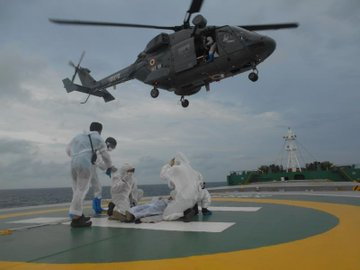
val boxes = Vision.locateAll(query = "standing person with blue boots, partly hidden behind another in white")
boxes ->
[91,137,117,214]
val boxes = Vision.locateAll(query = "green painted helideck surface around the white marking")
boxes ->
[0,191,360,269]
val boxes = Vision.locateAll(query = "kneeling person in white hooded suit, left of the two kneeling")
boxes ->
[108,163,144,222]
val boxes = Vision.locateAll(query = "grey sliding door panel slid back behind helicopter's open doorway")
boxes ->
[171,37,197,72]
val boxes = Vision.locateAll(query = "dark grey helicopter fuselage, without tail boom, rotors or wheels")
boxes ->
[134,26,276,96]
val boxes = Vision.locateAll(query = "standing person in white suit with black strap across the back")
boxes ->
[66,122,112,227]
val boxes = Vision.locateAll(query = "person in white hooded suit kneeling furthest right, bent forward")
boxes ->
[160,153,202,221]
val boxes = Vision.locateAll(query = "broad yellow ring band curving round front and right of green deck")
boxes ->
[0,198,360,270]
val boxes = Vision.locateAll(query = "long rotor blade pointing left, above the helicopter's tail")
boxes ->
[49,19,177,31]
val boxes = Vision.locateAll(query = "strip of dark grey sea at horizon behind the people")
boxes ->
[0,182,227,209]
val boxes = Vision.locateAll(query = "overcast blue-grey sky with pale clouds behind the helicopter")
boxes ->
[0,0,360,189]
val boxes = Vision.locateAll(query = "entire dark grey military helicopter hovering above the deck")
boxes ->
[49,0,298,108]
